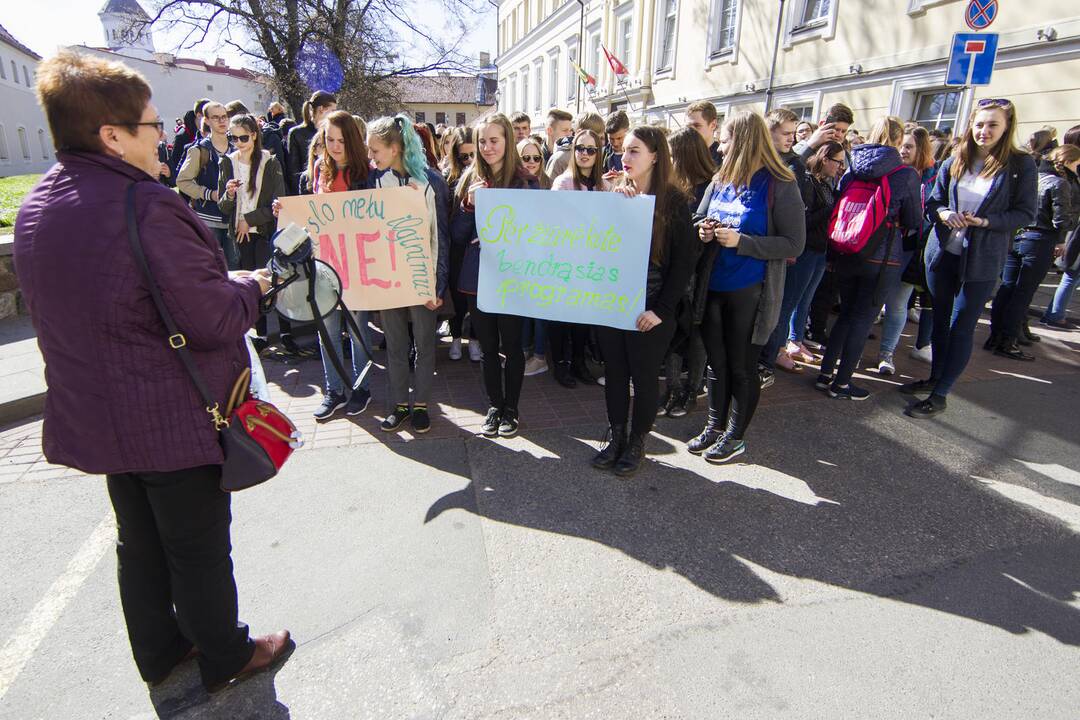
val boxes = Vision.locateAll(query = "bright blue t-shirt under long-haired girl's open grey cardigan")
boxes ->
[708,167,770,291]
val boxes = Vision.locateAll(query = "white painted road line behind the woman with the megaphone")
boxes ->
[0,515,117,701]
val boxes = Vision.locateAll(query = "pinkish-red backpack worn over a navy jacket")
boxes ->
[828,165,904,260]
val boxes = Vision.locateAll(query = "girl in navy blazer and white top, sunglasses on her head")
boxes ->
[900,99,1038,418]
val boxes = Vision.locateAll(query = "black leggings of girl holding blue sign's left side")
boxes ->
[467,295,525,412]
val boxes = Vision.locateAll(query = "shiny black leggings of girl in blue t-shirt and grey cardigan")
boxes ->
[701,283,761,439]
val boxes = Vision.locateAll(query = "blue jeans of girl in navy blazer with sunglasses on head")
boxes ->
[927,252,995,396]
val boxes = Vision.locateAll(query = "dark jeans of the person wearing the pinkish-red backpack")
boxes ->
[821,264,902,386]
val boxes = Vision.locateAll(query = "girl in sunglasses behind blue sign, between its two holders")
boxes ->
[548,130,611,388]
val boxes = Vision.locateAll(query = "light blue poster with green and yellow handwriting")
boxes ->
[476,190,654,330]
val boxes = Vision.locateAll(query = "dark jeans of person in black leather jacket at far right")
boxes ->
[990,231,1058,340]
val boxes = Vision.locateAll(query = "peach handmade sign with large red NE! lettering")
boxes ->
[278,187,435,310]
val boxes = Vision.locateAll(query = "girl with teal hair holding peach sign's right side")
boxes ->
[367,114,450,433]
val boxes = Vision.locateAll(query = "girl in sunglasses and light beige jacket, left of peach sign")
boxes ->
[217,114,285,351]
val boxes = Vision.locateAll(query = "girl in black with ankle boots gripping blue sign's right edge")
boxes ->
[591,125,698,477]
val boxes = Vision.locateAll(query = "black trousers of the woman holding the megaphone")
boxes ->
[106,465,255,685]
